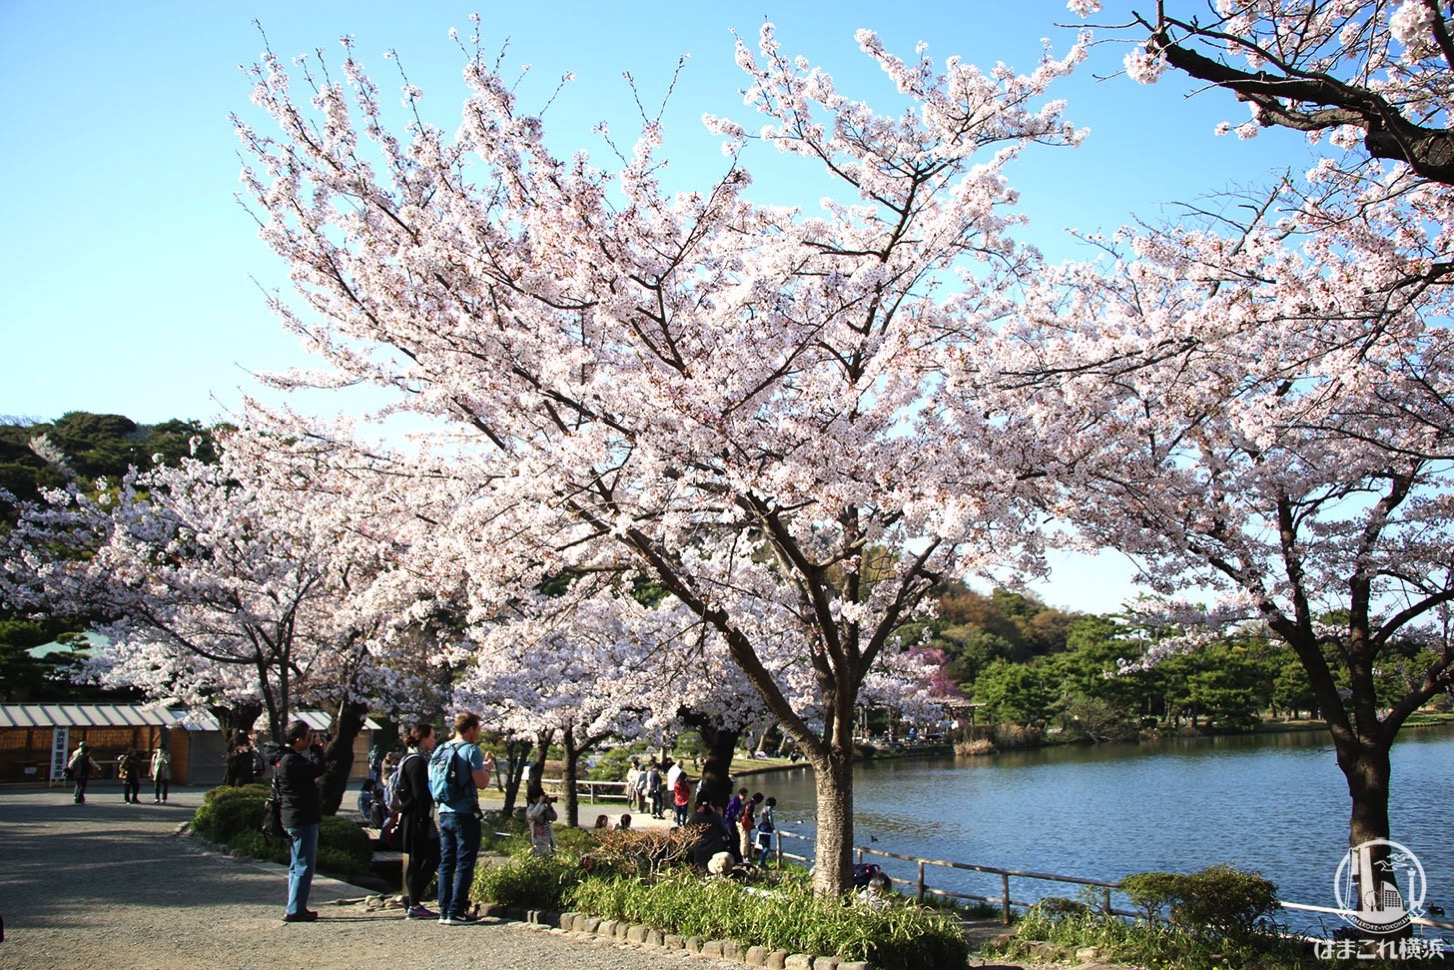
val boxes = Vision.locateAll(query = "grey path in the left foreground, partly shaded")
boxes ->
[0,787,743,970]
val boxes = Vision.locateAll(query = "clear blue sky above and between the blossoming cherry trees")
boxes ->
[0,0,1309,609]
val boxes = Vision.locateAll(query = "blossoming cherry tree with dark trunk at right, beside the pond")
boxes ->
[974,172,1454,901]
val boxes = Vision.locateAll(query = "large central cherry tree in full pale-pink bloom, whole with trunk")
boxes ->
[236,26,1083,893]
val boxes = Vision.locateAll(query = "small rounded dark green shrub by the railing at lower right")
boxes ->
[1121,865,1277,938]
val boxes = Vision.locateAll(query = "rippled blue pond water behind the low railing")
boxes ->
[749,727,1454,930]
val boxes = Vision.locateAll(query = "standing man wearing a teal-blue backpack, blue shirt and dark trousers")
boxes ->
[429,711,490,926]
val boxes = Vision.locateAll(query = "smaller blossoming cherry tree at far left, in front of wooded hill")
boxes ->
[6,432,425,762]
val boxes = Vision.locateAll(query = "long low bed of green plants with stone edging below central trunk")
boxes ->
[566,870,970,970]
